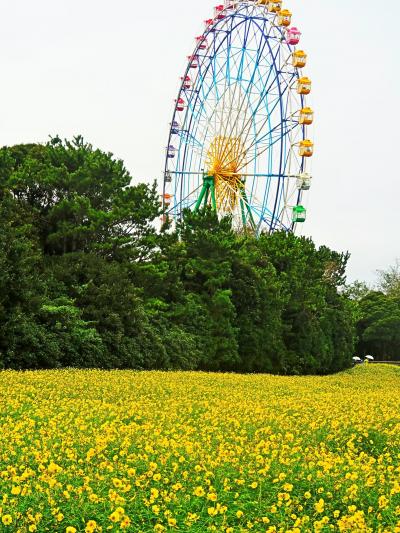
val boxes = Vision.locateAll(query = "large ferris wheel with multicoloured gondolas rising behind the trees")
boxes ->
[163,0,314,234]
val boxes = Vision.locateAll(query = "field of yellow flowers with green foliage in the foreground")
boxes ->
[0,365,400,533]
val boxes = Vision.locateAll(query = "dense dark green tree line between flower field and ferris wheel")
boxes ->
[0,137,357,374]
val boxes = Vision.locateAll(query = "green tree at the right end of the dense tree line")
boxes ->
[260,232,354,374]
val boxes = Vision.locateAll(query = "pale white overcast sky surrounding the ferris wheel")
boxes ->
[0,0,400,281]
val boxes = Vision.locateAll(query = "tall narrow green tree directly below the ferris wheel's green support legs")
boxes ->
[176,209,239,370]
